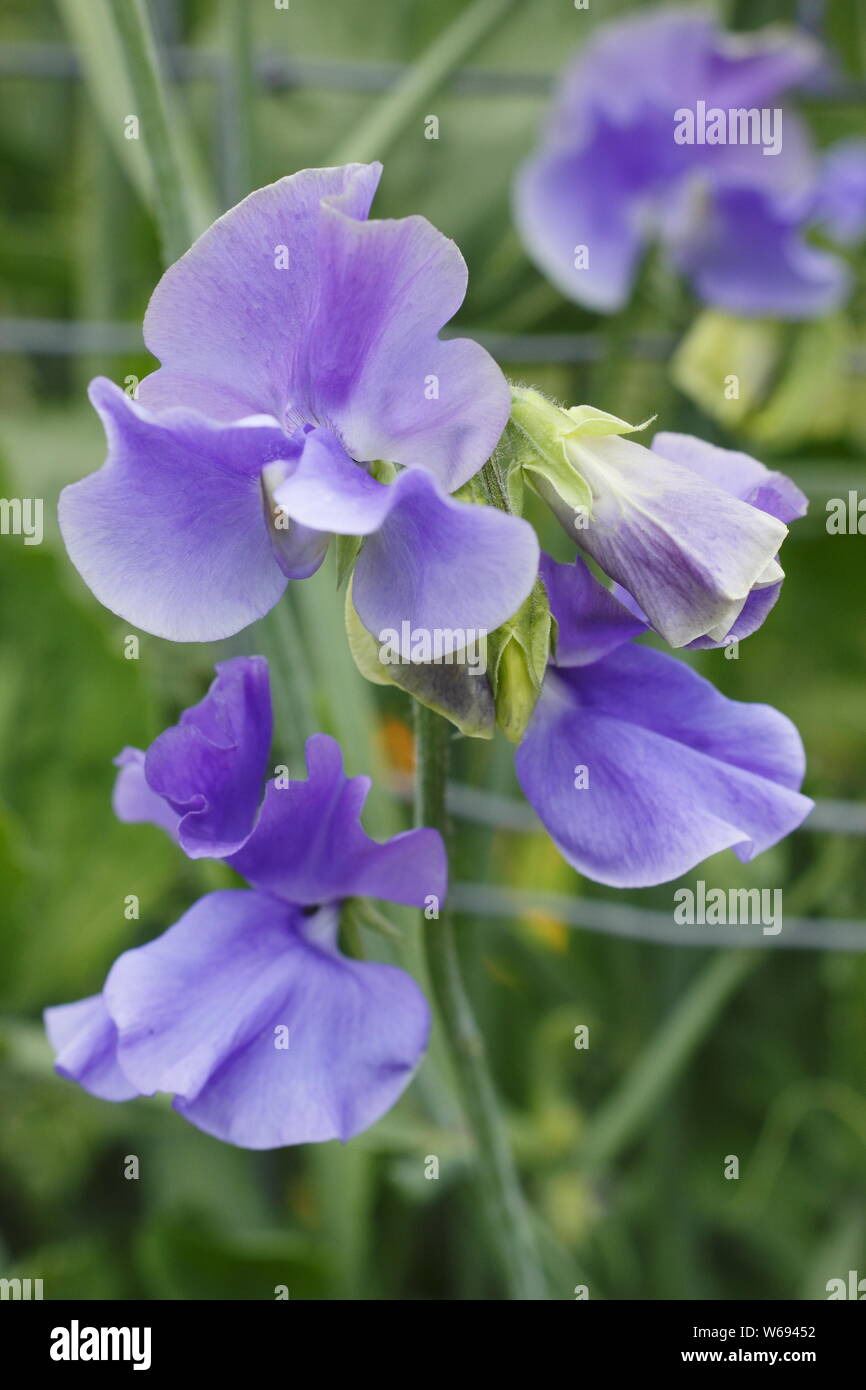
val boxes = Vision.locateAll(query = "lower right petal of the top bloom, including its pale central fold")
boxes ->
[274,444,538,657]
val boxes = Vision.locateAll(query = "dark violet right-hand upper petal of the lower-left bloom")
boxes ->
[229,734,448,906]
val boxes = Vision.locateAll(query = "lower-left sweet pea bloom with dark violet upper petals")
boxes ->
[46,657,446,1148]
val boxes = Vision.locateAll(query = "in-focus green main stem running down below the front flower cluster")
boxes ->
[416,703,548,1300]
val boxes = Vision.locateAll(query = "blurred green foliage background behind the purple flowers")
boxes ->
[0,0,866,1300]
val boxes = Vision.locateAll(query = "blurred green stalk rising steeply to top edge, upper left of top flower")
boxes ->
[110,0,209,264]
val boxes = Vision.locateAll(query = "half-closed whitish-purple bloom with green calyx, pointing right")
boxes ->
[512,388,806,646]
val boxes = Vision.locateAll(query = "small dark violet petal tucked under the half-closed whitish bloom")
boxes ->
[539,552,646,666]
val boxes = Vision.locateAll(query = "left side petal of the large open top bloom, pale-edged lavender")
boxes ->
[60,378,293,642]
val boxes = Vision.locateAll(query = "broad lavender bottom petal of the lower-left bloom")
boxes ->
[104,891,430,1148]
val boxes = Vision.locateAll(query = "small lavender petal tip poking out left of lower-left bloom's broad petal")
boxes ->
[44,994,140,1101]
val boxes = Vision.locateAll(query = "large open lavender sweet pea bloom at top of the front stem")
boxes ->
[60,164,538,656]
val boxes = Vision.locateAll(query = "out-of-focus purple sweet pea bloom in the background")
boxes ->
[514,7,849,318]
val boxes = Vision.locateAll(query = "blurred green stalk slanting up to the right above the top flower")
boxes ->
[331,0,516,164]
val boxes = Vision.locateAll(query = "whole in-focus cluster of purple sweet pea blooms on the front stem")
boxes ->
[46,154,811,1148]
